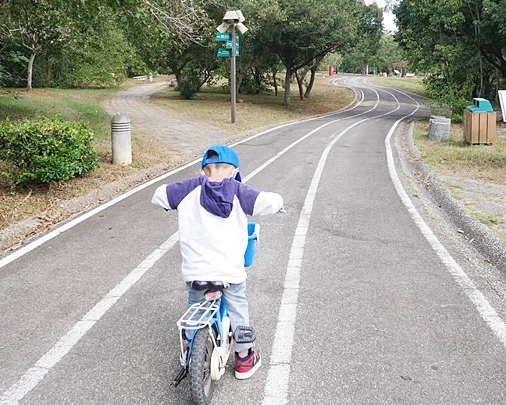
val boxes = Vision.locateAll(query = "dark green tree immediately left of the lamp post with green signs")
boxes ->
[121,0,218,98]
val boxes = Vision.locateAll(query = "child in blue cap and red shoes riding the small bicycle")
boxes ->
[151,146,283,380]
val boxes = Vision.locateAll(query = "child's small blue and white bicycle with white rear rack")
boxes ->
[174,222,260,405]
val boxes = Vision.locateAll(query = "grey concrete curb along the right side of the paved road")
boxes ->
[406,122,506,277]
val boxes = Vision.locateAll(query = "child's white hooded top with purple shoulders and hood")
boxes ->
[151,176,283,284]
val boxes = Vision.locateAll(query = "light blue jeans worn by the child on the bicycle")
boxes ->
[186,281,254,352]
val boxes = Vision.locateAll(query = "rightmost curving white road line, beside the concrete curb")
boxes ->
[385,118,506,347]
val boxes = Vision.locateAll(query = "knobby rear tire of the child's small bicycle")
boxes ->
[188,326,215,405]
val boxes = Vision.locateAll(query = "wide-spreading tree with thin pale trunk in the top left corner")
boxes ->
[0,0,211,90]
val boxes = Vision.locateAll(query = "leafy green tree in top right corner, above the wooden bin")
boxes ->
[394,0,506,96]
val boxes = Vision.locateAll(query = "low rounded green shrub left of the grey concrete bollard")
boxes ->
[0,115,98,187]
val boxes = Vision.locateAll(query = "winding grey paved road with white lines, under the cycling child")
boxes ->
[0,78,506,405]
